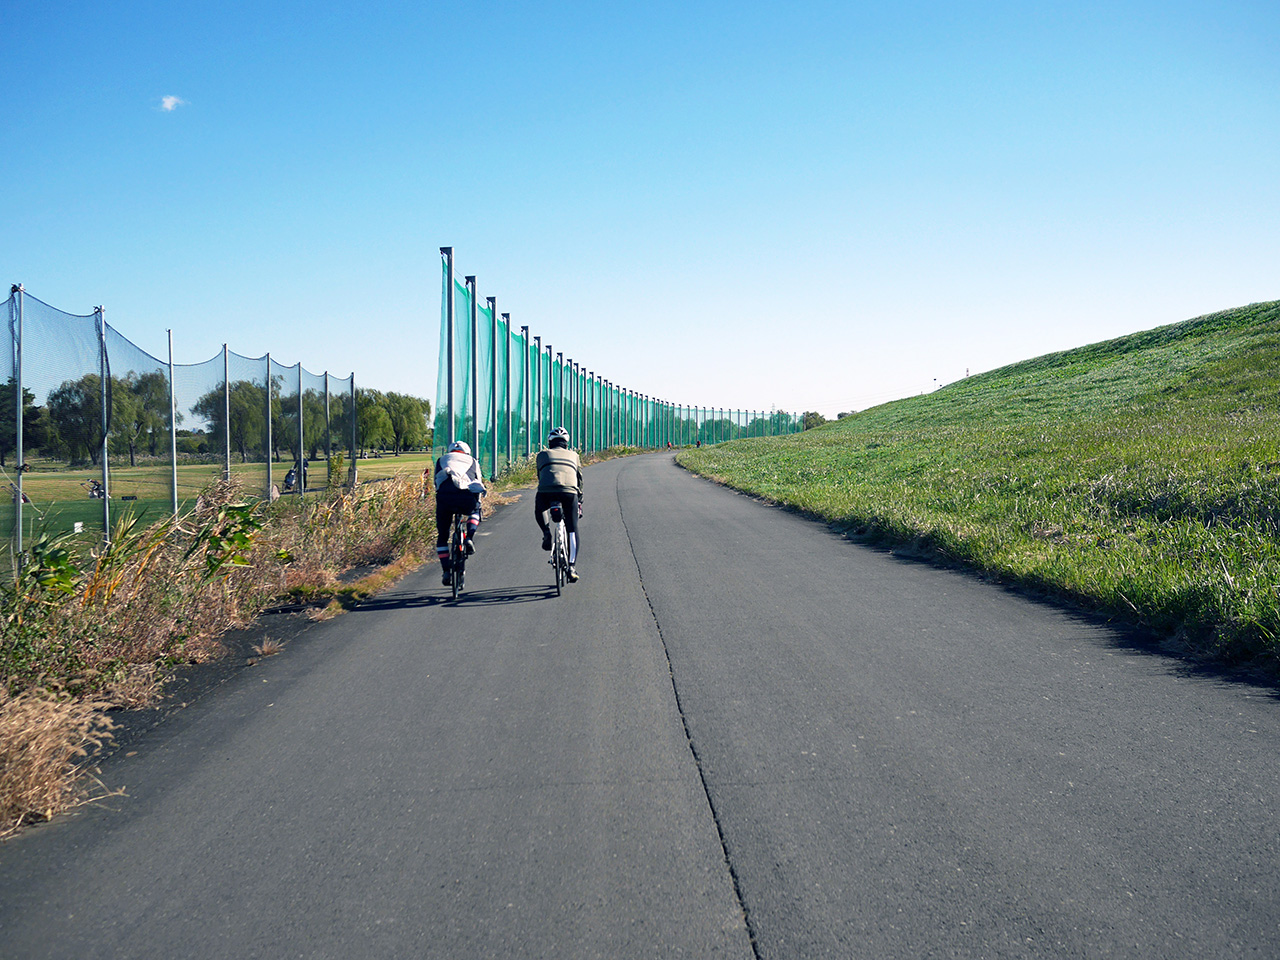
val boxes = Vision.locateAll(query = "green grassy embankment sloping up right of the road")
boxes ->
[680,302,1280,668]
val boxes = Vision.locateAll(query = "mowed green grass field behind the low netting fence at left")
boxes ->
[0,453,431,539]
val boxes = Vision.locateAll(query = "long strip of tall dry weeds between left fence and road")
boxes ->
[8,479,435,707]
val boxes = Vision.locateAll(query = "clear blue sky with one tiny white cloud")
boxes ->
[0,0,1280,416]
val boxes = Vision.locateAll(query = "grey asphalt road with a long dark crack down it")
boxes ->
[0,454,1280,960]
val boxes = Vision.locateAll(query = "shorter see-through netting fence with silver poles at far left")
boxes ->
[0,285,360,550]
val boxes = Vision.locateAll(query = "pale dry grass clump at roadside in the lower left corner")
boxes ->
[0,687,114,838]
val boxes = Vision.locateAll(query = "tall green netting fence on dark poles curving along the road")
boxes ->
[433,247,804,476]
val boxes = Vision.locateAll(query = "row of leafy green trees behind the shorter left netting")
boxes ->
[0,371,431,467]
